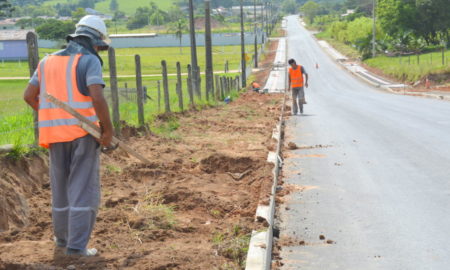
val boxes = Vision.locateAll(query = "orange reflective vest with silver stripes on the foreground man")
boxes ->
[38,54,98,148]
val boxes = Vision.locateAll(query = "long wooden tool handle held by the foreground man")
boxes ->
[44,93,150,163]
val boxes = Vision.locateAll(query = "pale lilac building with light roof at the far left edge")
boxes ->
[0,30,29,61]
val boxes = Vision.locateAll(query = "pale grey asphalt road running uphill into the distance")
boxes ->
[278,16,450,270]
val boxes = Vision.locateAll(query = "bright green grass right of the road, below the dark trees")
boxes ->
[364,50,450,82]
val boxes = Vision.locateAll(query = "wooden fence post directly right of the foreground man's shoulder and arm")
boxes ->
[108,47,121,136]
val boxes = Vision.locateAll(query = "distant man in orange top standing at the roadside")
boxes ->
[288,59,308,115]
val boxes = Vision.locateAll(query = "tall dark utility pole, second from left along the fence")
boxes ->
[205,0,214,100]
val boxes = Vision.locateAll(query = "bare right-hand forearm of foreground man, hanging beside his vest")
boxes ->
[88,84,113,147]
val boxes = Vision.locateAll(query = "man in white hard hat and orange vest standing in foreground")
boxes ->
[24,15,113,256]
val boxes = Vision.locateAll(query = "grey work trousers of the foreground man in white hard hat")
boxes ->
[50,135,100,250]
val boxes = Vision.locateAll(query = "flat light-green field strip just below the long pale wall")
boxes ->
[0,45,253,77]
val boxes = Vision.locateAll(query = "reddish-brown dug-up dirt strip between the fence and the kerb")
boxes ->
[0,40,282,270]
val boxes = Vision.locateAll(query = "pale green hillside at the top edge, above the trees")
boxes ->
[45,0,175,15]
